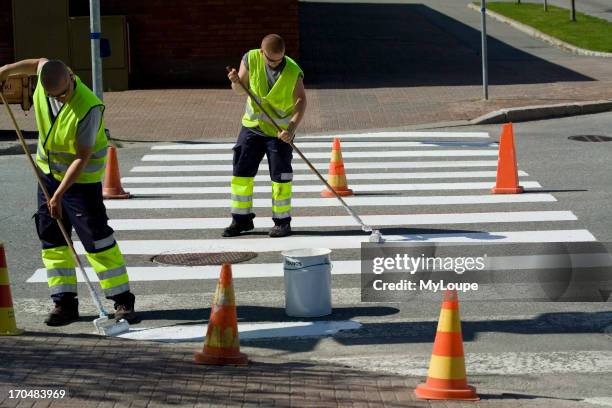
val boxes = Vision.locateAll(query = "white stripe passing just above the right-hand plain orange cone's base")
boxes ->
[121,169,529,184]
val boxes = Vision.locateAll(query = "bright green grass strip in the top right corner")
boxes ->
[476,0,612,52]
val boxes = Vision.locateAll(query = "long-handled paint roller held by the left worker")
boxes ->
[0,91,130,336]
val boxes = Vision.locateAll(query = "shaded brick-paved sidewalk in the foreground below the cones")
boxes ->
[0,332,590,408]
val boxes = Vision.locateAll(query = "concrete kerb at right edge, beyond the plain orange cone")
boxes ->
[470,100,612,125]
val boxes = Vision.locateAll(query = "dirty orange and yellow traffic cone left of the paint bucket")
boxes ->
[194,264,248,365]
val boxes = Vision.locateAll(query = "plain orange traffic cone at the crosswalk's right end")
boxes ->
[491,123,523,194]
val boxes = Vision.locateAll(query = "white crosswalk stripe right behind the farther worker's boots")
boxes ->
[109,211,578,231]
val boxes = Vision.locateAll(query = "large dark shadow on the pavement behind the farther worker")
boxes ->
[299,2,592,88]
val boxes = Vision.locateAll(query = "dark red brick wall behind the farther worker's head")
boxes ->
[70,0,299,88]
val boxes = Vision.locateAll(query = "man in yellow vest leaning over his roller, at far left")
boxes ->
[0,58,138,326]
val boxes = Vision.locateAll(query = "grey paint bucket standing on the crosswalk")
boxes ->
[282,248,332,317]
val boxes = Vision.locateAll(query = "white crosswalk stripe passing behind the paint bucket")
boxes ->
[26,253,612,283]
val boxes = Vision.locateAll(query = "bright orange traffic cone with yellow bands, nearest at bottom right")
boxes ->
[415,290,480,401]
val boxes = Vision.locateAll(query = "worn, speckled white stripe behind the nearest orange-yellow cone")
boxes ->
[325,350,612,376]
